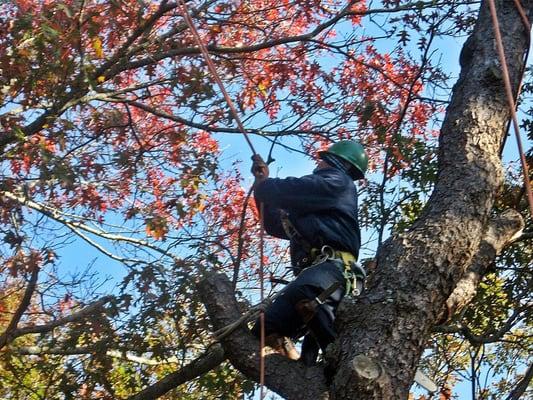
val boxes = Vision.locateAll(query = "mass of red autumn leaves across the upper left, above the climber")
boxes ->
[0,0,434,276]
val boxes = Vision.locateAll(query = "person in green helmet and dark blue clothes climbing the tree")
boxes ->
[248,140,368,366]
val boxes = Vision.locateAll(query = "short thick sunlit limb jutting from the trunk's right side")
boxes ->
[441,210,524,323]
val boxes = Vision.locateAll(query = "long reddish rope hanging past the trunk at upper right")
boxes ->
[489,0,533,217]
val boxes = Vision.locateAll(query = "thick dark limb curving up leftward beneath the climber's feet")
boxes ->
[198,272,328,400]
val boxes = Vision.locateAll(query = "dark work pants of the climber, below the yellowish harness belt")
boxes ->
[252,260,345,351]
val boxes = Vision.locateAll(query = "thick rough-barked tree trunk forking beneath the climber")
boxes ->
[197,0,533,400]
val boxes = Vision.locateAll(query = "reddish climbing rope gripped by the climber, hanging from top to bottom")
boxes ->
[178,0,265,399]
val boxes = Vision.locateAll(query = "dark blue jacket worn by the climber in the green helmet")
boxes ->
[255,168,361,265]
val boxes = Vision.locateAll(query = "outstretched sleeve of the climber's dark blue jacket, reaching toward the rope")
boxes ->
[255,173,346,213]
